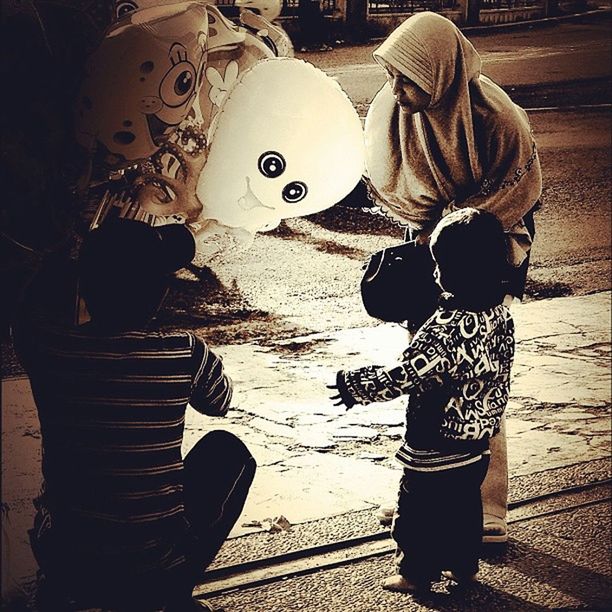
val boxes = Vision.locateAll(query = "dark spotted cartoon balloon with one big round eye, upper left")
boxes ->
[76,2,208,167]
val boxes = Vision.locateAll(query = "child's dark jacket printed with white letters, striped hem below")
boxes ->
[341,302,514,471]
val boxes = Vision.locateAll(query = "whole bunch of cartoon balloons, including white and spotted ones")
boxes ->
[80,4,365,263]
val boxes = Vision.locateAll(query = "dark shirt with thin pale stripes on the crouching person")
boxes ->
[17,324,232,571]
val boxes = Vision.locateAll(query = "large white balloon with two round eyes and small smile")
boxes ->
[196,58,364,232]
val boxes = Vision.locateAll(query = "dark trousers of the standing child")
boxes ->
[391,455,489,584]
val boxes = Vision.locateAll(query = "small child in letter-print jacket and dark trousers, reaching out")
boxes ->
[330,208,514,592]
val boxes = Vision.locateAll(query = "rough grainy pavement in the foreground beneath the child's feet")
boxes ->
[202,460,612,612]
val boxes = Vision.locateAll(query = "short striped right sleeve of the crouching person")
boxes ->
[189,335,233,416]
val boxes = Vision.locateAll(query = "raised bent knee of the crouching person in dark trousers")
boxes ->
[183,430,257,575]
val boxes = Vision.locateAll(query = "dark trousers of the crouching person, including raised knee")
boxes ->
[37,430,256,612]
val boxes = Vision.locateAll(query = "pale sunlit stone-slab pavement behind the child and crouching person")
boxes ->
[2,292,611,612]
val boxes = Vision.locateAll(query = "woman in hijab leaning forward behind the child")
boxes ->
[365,12,542,560]
